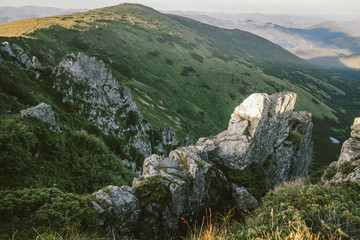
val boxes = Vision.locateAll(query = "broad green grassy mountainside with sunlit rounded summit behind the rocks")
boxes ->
[0,4,360,175]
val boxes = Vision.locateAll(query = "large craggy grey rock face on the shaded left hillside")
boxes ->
[53,53,151,156]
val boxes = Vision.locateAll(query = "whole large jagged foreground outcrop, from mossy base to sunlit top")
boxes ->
[93,92,312,239]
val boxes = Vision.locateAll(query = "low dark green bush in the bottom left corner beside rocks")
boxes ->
[0,188,99,239]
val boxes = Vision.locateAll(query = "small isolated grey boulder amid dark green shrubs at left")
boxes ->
[20,103,60,132]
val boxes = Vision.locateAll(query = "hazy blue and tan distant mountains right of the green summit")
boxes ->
[169,11,360,79]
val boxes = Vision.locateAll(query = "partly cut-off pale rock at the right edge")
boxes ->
[321,117,360,186]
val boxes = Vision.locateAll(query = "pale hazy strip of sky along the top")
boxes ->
[0,0,360,17]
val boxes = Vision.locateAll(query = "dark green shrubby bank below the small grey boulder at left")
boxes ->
[0,115,135,193]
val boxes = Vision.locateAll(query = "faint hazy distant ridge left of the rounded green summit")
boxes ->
[0,6,85,24]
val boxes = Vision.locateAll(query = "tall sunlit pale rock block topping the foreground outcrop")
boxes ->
[196,92,313,187]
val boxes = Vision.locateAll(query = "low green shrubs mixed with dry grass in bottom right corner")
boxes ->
[239,182,360,239]
